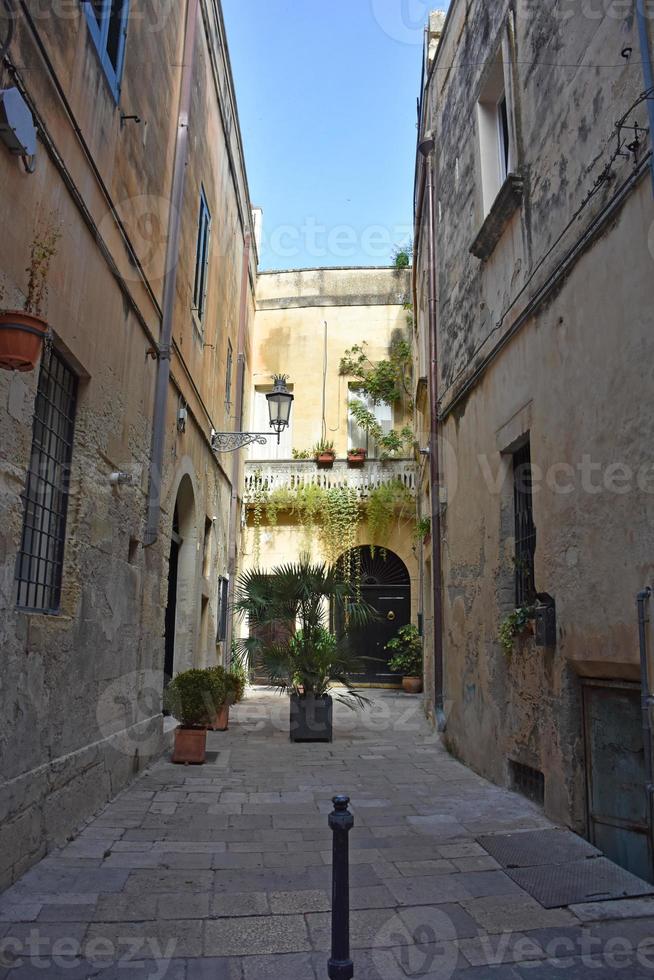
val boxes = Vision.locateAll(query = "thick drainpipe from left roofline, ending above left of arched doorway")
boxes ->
[144,0,200,548]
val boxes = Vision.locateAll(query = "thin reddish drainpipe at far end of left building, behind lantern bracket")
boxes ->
[224,229,251,667]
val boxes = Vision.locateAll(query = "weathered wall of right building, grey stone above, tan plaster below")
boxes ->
[416,2,654,830]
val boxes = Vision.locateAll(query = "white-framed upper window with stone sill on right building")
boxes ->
[477,49,515,217]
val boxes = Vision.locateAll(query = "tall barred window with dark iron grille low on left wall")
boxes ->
[16,347,78,615]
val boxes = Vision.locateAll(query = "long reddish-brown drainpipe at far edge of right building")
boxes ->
[418,136,446,732]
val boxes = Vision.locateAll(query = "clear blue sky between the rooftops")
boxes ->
[223,0,444,269]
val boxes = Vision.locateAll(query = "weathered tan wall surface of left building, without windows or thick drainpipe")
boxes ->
[0,3,256,887]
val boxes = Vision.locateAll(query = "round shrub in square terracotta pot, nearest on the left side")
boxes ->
[164,669,224,766]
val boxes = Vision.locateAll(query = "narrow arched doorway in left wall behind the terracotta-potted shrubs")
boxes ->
[164,476,198,683]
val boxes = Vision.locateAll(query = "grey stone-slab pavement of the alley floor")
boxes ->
[0,689,654,980]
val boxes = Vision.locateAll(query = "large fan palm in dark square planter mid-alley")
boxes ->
[235,556,375,742]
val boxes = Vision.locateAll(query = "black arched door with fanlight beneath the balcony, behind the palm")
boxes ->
[336,545,411,686]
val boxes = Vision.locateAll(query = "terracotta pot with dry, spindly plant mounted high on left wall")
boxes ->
[0,225,61,371]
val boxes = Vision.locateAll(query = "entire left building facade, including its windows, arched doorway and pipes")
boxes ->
[0,0,256,887]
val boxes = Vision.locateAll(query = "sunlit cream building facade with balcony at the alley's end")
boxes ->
[243,268,421,685]
